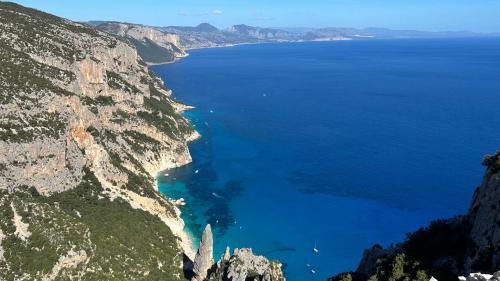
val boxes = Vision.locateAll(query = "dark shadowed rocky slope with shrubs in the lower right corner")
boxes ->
[329,151,500,281]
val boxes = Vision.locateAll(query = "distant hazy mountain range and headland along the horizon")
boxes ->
[87,21,500,64]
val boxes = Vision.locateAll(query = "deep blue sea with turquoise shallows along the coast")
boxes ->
[153,39,500,281]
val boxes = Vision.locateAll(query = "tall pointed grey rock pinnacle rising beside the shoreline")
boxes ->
[192,224,214,281]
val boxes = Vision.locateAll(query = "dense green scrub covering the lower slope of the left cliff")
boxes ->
[0,169,182,280]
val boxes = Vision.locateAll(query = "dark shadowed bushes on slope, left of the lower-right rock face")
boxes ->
[329,217,470,281]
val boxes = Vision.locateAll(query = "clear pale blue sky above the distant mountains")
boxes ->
[9,0,500,32]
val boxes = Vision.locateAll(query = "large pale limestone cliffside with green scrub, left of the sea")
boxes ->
[0,2,197,280]
